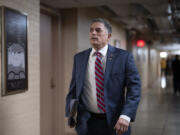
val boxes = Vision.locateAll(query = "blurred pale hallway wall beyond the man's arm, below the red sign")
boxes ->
[132,44,159,90]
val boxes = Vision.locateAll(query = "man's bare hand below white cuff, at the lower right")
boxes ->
[114,118,129,135]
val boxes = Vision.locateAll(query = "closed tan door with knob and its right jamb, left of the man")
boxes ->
[40,12,64,135]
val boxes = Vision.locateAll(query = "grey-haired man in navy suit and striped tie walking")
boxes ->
[66,18,141,135]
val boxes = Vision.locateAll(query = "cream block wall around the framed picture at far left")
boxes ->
[0,0,40,135]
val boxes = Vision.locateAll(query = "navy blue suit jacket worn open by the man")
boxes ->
[66,45,141,134]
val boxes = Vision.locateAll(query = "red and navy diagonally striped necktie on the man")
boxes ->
[95,52,105,113]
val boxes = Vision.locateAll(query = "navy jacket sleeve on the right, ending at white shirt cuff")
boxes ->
[121,53,141,122]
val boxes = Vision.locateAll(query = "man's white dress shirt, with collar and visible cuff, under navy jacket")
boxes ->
[82,45,130,122]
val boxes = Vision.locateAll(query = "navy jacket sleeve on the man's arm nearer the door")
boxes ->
[65,56,76,117]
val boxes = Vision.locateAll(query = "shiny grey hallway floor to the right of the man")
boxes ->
[132,76,180,135]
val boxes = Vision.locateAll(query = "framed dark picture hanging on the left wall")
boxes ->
[0,7,28,96]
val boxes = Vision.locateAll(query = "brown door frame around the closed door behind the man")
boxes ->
[40,4,65,135]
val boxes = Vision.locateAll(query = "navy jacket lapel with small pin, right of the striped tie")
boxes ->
[104,45,115,87]
